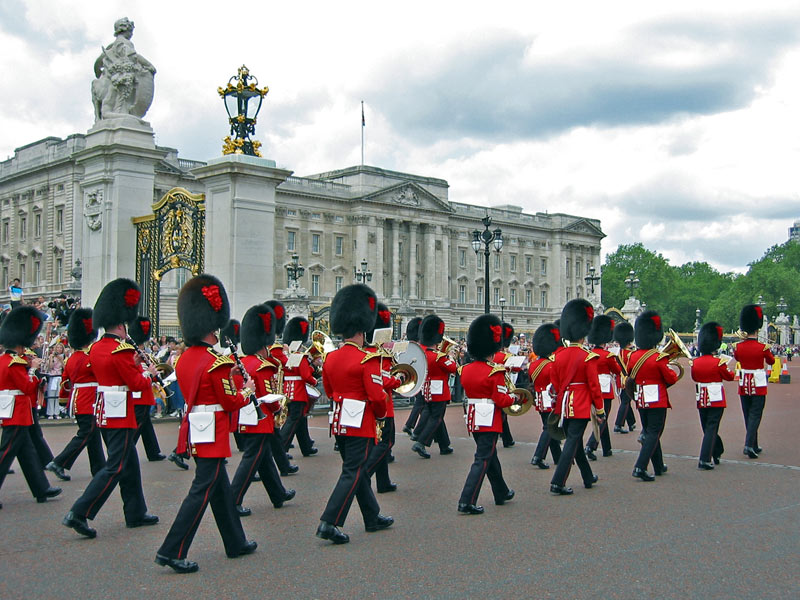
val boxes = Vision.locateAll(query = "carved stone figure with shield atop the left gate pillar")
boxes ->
[92,17,156,121]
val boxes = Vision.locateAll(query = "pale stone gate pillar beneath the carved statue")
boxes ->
[73,117,166,306]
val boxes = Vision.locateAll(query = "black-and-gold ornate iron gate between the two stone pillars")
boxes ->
[132,188,206,336]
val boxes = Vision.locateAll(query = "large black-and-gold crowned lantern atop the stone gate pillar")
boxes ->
[217,65,269,156]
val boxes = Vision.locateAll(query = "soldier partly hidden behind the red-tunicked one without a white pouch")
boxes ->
[529,323,563,469]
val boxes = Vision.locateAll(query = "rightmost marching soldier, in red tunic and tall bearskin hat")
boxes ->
[733,304,775,458]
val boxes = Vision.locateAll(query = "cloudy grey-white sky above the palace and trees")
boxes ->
[0,0,800,271]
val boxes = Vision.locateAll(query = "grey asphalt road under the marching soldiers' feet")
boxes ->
[0,361,800,599]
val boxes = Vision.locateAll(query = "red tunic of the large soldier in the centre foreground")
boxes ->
[322,342,386,438]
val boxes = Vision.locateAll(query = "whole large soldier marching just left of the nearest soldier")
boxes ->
[62,278,158,538]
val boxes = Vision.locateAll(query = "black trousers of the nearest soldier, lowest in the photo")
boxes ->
[158,458,247,559]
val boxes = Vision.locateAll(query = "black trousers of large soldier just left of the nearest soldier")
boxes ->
[72,428,147,523]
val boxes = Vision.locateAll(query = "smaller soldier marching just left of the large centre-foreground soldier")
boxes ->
[280,317,318,456]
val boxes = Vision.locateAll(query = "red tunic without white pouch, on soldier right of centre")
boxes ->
[550,345,603,419]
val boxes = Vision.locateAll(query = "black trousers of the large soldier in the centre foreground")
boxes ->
[320,435,381,527]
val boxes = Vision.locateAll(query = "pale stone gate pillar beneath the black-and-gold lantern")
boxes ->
[192,154,292,319]
